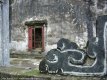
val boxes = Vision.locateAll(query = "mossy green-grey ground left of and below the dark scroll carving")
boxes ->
[0,58,107,80]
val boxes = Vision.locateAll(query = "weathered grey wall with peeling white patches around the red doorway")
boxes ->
[11,0,107,51]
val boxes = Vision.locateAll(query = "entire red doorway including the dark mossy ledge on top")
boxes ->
[25,20,47,51]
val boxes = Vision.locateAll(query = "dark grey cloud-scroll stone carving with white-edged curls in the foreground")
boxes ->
[39,15,107,76]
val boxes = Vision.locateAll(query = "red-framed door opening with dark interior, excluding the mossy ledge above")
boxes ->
[28,27,44,51]
